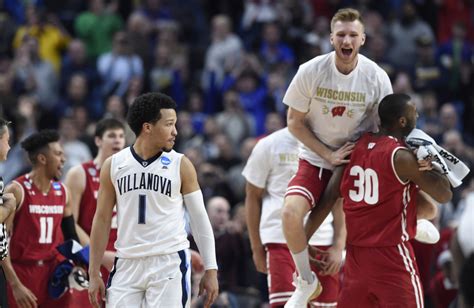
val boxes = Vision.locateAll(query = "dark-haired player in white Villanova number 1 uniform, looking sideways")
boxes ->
[89,93,218,307]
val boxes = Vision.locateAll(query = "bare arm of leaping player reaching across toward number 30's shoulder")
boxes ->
[287,107,354,166]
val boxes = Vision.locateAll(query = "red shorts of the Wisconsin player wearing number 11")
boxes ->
[8,259,70,308]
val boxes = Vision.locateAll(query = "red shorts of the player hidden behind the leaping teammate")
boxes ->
[266,244,339,308]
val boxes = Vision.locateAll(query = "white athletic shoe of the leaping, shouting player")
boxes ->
[285,272,323,308]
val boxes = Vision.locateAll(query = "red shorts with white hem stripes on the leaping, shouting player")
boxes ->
[285,159,332,208]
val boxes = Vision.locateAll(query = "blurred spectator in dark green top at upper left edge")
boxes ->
[74,0,123,60]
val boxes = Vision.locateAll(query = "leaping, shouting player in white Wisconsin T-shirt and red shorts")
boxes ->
[282,8,436,307]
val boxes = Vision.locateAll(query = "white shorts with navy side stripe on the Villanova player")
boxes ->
[106,249,191,308]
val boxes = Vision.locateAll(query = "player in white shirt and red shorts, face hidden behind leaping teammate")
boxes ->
[242,128,346,308]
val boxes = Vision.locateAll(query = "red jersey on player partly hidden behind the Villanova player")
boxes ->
[78,160,117,250]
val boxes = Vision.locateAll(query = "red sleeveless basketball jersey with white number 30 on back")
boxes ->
[340,133,417,247]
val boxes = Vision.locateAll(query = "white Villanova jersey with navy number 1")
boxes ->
[110,146,189,258]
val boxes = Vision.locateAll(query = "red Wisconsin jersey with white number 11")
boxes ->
[10,174,66,263]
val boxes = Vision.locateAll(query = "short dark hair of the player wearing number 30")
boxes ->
[379,93,411,128]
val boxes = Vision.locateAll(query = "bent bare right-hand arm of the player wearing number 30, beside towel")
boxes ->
[394,150,453,203]
